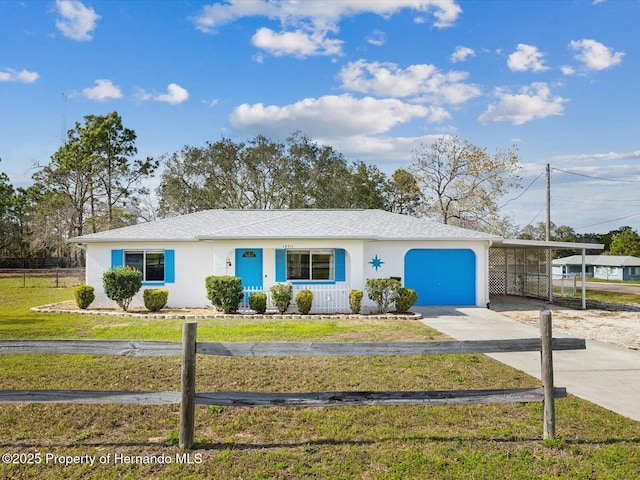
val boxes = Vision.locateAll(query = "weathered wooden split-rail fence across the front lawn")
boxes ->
[0,311,586,449]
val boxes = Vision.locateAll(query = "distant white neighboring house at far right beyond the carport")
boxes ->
[553,255,640,280]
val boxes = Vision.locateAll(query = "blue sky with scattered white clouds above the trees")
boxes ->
[0,0,640,233]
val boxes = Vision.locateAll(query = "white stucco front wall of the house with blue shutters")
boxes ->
[81,238,489,307]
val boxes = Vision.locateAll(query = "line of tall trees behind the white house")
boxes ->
[0,112,640,264]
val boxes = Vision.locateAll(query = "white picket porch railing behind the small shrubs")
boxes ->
[240,284,351,313]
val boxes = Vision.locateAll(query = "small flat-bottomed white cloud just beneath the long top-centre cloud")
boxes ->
[251,28,343,58]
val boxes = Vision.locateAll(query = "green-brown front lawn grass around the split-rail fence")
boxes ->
[0,281,640,479]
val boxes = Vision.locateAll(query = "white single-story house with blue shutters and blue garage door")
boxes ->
[71,209,498,312]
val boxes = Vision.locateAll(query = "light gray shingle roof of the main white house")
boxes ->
[71,209,498,243]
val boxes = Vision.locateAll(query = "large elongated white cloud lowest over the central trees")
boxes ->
[229,94,430,138]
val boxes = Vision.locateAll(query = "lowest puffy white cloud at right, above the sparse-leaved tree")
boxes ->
[478,83,568,125]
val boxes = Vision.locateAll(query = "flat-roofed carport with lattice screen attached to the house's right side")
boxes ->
[489,239,604,309]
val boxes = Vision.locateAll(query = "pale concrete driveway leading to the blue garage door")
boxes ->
[413,307,640,421]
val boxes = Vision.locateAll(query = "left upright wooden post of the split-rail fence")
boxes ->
[179,322,198,450]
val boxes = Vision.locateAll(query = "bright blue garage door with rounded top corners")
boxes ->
[404,249,476,305]
